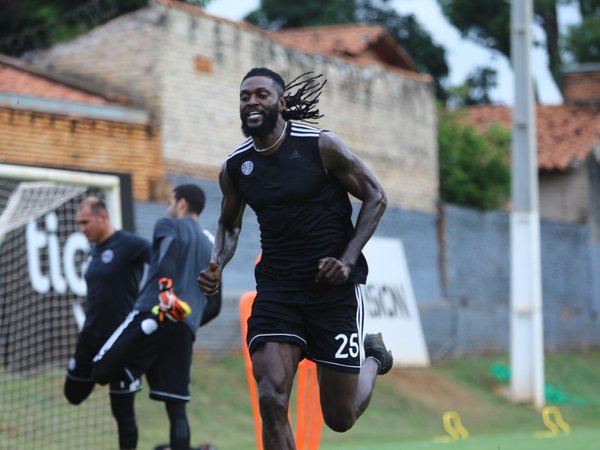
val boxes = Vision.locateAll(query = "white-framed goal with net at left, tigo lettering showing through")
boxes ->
[0,164,121,450]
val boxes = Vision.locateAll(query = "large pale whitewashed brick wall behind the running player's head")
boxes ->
[31,3,438,212]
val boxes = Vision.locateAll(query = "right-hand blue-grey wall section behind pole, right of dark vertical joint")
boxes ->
[439,206,600,356]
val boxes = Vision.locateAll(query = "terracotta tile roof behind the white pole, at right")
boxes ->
[467,105,600,171]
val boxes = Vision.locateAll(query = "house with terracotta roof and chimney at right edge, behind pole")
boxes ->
[467,64,600,243]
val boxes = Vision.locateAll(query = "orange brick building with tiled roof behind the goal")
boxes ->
[0,51,164,200]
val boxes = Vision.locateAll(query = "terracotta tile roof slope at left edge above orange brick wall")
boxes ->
[0,55,125,105]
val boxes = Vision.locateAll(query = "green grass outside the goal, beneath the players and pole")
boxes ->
[132,352,600,450]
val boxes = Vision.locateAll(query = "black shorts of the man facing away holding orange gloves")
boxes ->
[96,310,195,402]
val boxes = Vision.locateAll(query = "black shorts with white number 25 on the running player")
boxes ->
[247,283,364,373]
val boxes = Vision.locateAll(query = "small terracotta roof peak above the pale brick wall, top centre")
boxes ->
[270,23,415,71]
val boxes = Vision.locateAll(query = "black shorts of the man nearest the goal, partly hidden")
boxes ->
[67,330,141,394]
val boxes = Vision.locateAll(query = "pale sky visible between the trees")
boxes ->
[206,0,580,105]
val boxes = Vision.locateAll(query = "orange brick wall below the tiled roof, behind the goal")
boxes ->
[0,108,164,201]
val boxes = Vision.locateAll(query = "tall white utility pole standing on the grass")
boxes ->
[510,0,544,409]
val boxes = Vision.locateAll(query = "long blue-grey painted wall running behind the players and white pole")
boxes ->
[135,177,600,359]
